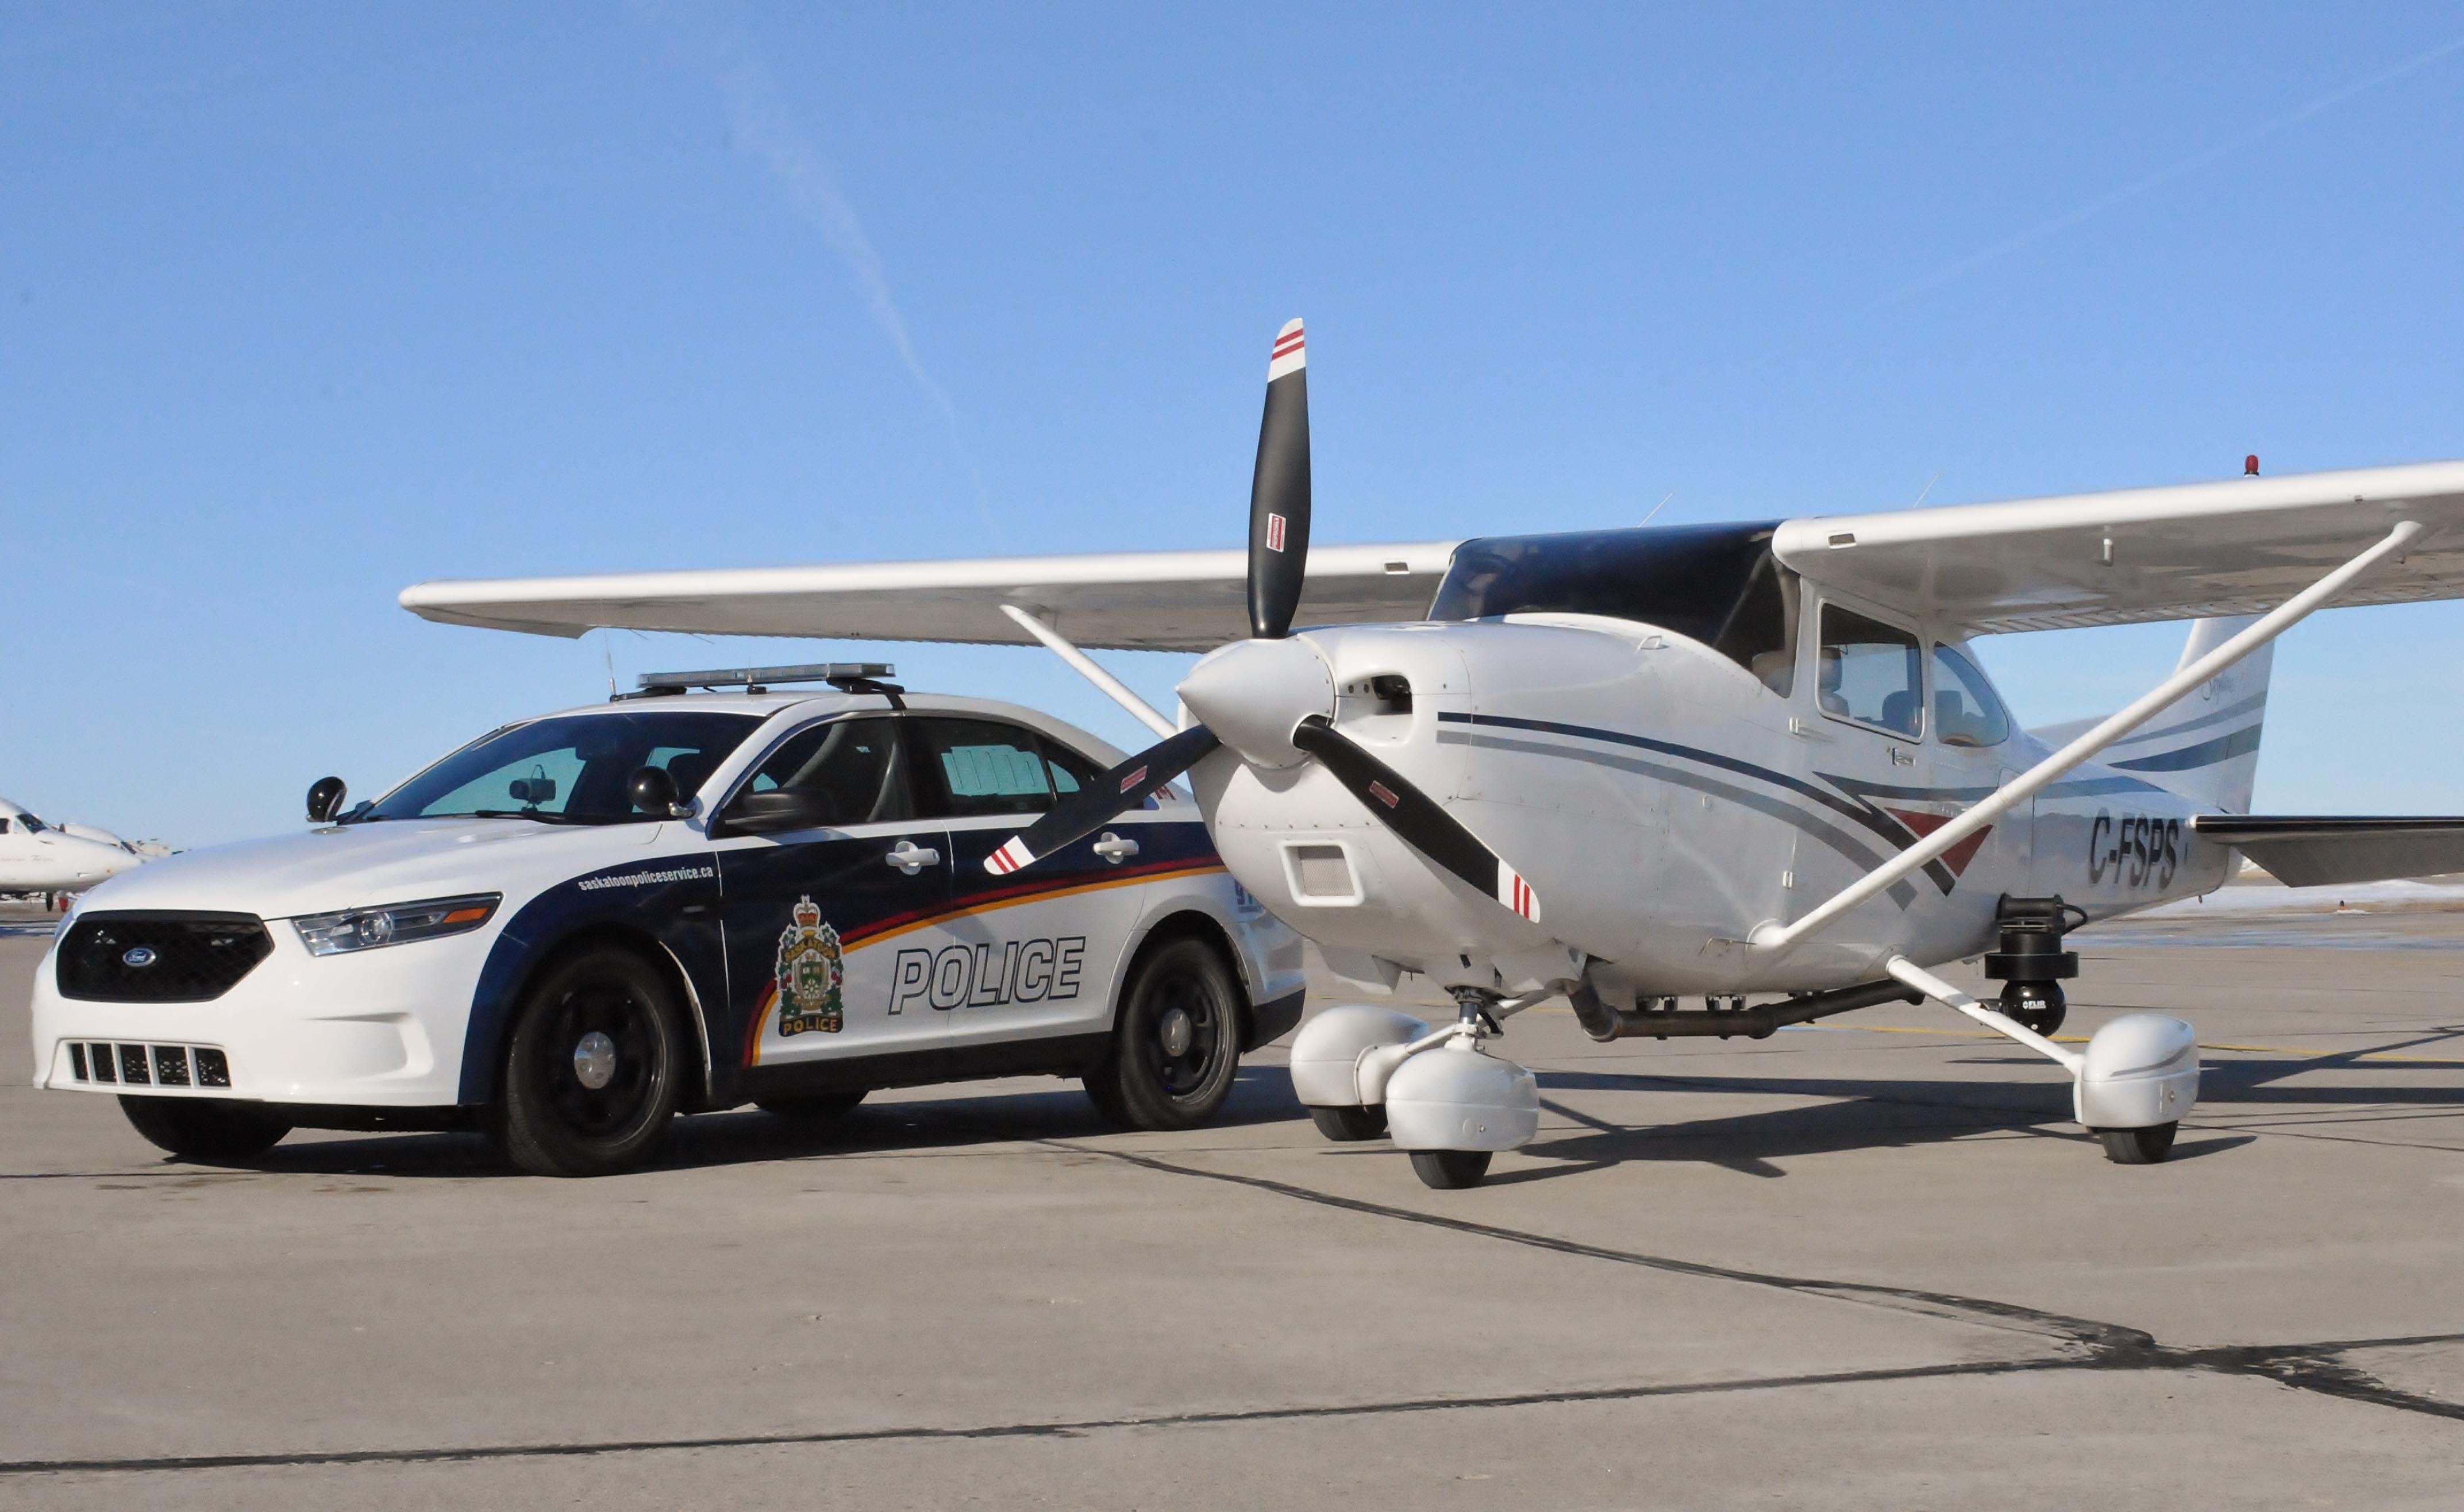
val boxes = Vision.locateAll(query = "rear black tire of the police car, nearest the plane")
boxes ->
[1087,938,1242,1131]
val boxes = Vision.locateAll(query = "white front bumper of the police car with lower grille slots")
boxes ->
[32,919,498,1108]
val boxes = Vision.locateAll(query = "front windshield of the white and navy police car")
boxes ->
[350,709,761,825]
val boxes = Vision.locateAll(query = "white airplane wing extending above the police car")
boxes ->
[402,542,1458,650]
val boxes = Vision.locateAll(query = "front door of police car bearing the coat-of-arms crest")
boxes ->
[712,716,951,1066]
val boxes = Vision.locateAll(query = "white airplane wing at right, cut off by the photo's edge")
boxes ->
[1772,463,2464,633]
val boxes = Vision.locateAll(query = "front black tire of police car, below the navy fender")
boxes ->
[495,948,685,1177]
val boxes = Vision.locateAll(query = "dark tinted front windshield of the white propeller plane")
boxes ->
[1429,524,1796,695]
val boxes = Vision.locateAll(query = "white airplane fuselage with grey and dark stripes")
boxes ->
[1192,606,2232,995]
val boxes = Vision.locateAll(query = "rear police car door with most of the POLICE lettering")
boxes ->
[895,714,1150,1049]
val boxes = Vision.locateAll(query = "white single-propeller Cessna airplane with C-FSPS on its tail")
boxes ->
[402,320,2464,1187]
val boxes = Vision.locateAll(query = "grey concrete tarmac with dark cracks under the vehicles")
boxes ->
[0,911,2464,1512]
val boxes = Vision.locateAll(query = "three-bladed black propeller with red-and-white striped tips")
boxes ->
[983,320,1540,921]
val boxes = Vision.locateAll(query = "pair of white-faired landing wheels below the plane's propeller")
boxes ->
[1291,988,1545,1189]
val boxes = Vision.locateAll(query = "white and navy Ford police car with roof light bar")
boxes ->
[34,665,1301,1175]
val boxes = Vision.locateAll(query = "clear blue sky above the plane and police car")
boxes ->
[0,5,2464,844]
